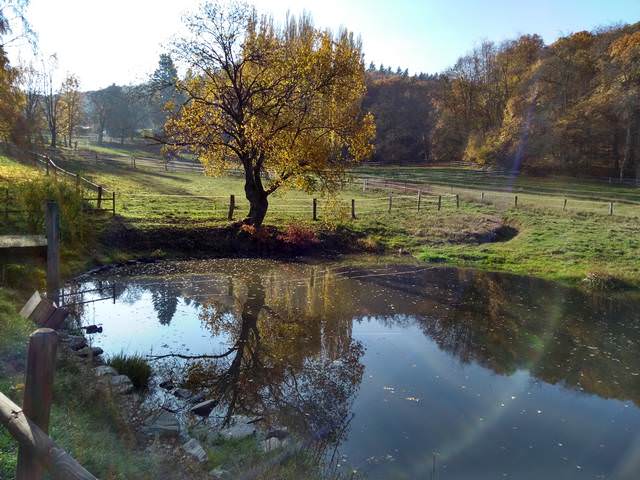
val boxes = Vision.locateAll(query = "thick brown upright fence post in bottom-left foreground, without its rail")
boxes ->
[16,328,58,480]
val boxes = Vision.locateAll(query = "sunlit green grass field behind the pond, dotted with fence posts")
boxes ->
[3,147,640,286]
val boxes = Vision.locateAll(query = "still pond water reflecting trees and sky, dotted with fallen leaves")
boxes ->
[68,259,640,480]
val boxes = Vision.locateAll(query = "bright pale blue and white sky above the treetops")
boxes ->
[8,0,640,90]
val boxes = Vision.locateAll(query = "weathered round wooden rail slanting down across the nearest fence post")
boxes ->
[0,393,97,480]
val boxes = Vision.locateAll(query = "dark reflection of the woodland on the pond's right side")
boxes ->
[392,271,640,405]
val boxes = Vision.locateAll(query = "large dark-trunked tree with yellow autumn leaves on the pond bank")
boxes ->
[162,3,375,226]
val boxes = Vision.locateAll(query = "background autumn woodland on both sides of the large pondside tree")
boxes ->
[0,0,640,178]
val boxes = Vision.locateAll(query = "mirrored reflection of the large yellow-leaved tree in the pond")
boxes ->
[188,275,363,450]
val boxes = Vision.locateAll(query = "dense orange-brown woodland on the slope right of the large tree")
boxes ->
[366,23,640,178]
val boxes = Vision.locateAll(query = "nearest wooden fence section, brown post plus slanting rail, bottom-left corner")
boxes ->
[0,328,96,480]
